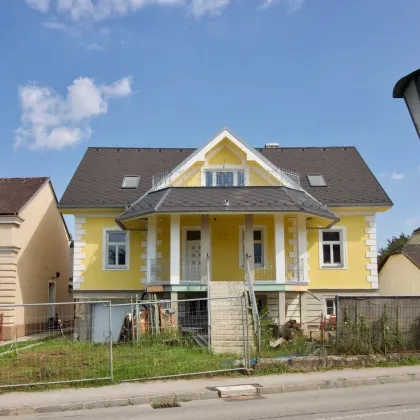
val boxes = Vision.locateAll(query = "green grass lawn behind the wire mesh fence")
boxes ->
[0,338,244,385]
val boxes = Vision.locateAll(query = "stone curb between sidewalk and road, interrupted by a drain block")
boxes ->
[0,374,420,417]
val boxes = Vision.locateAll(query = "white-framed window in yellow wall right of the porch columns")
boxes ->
[320,228,346,268]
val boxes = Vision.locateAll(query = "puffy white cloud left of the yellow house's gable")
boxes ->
[14,77,132,150]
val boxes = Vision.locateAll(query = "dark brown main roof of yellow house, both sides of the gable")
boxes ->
[60,147,392,208]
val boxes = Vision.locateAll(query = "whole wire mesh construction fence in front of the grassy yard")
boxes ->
[0,295,251,388]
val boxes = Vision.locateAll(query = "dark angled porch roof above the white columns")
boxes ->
[117,187,338,221]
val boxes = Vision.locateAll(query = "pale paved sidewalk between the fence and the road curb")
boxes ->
[0,366,420,416]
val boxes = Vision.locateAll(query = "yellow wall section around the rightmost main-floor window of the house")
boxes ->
[307,216,371,289]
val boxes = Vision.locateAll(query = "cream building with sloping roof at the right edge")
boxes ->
[379,228,420,296]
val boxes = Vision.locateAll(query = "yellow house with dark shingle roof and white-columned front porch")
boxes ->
[59,129,392,325]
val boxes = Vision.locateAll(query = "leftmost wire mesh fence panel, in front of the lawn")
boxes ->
[0,302,112,387]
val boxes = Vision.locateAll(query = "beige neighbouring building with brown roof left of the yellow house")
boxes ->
[0,178,72,340]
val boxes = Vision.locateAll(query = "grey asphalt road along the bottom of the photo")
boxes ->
[18,382,420,420]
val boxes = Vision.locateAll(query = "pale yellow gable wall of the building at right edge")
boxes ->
[379,254,420,296]
